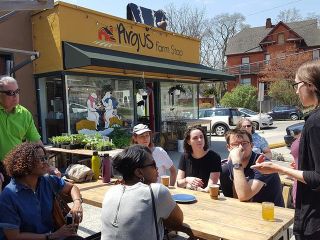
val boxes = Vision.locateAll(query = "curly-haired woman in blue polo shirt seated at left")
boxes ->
[0,142,82,240]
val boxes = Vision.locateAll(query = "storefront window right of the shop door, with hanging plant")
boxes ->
[160,82,198,120]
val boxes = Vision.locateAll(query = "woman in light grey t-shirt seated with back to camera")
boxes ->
[101,145,183,240]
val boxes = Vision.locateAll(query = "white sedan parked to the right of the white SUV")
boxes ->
[238,108,273,129]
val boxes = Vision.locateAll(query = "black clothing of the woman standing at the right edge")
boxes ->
[293,108,320,235]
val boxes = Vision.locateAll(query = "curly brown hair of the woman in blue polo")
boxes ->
[3,142,46,178]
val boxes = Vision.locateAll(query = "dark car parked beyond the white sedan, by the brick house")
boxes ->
[268,105,303,120]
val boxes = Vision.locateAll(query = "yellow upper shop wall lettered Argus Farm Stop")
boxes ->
[33,2,200,73]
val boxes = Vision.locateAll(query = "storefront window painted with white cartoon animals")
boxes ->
[66,75,134,133]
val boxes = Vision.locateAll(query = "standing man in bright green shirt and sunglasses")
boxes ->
[0,76,42,189]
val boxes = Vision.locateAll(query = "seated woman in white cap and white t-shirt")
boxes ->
[132,124,177,186]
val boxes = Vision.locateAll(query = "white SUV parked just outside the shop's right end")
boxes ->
[199,108,242,136]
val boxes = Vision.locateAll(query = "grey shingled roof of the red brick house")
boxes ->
[226,19,320,55]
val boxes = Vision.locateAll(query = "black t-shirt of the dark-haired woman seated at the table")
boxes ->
[179,150,221,188]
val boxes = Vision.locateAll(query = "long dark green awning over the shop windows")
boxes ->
[63,42,235,81]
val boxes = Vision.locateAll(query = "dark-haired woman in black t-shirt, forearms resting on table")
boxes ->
[177,126,221,192]
